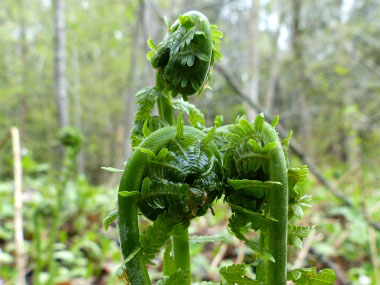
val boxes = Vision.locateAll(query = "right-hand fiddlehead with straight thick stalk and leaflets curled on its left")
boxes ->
[222,114,288,284]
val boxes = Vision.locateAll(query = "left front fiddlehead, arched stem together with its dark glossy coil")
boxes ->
[119,121,222,284]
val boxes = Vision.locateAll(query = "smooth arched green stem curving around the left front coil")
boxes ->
[118,126,220,285]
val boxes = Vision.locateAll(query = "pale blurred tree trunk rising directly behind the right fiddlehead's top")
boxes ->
[247,0,260,120]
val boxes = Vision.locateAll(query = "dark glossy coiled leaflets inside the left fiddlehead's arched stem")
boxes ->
[137,115,223,221]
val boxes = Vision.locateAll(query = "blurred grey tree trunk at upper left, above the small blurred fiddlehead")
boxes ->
[54,0,70,128]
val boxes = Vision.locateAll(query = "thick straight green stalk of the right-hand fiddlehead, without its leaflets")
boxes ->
[263,123,288,285]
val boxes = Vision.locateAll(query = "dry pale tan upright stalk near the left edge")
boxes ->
[11,128,25,285]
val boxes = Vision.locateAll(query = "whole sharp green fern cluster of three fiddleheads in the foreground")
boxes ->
[104,11,335,285]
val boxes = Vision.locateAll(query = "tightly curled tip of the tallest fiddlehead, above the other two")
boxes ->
[148,11,222,100]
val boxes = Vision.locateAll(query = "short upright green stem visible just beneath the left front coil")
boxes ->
[172,224,191,285]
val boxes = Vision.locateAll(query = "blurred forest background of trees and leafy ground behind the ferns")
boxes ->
[0,0,380,285]
